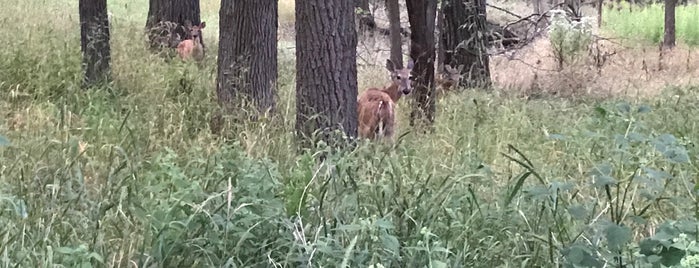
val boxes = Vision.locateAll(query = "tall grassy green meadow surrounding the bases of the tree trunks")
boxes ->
[0,0,699,267]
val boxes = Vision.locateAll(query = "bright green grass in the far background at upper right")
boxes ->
[602,2,699,47]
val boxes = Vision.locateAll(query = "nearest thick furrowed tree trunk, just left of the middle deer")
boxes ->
[296,0,357,146]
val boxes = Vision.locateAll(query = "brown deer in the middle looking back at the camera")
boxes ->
[357,59,414,141]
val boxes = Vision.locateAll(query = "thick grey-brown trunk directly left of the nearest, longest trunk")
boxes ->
[216,0,277,120]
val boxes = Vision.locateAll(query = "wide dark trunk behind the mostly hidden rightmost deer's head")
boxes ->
[442,0,491,88]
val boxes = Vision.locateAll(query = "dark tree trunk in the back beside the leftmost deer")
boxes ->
[146,0,206,50]
